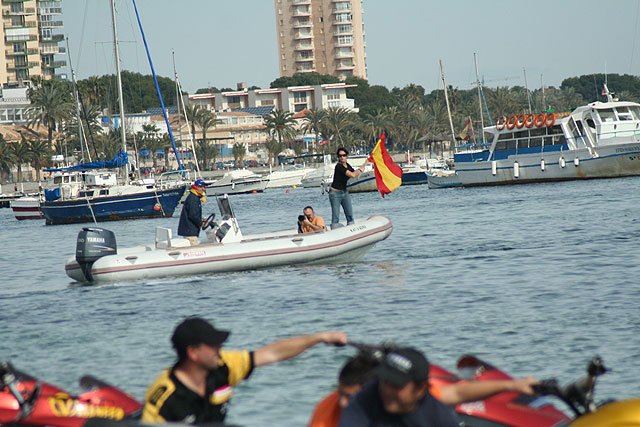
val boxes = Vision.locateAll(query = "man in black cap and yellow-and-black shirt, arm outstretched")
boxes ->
[142,317,347,424]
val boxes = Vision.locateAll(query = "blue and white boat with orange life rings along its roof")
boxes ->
[429,86,640,188]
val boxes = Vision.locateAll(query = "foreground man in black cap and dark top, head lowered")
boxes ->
[339,347,459,427]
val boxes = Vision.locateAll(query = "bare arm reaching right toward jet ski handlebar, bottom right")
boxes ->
[440,377,538,405]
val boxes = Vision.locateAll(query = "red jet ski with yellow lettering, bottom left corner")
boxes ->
[0,362,142,427]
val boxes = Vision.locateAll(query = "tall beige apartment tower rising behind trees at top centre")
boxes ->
[275,0,367,79]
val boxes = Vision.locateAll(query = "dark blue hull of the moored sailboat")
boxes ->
[41,187,185,224]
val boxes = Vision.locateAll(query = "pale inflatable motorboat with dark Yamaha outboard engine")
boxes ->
[65,197,393,282]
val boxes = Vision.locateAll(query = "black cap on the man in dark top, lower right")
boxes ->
[375,347,429,387]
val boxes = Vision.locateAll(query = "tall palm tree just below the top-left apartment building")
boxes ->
[27,81,73,149]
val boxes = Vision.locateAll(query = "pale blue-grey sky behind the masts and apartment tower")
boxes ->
[60,0,640,93]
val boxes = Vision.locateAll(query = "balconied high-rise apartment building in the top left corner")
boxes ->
[0,0,67,83]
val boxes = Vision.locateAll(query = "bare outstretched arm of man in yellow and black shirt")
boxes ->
[253,331,347,366]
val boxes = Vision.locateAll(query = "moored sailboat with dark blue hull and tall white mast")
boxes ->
[41,0,186,224]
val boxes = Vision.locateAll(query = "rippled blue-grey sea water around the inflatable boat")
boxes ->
[0,178,640,426]
